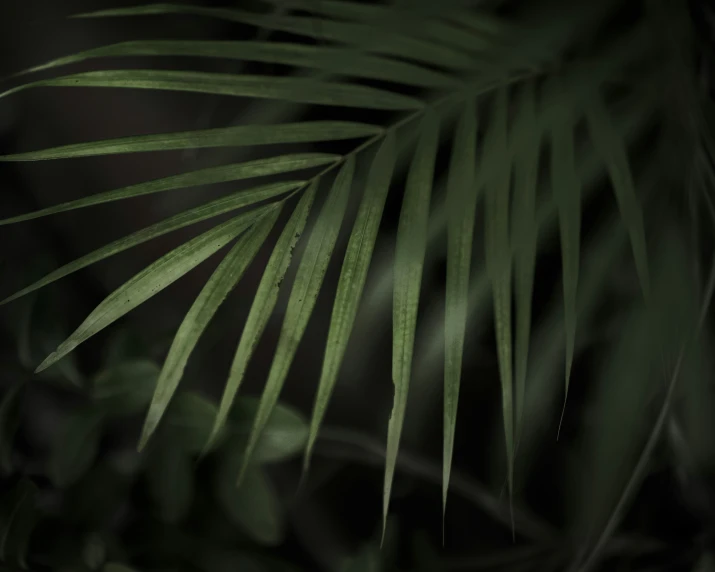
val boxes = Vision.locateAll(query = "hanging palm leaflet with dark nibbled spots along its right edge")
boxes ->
[205,183,317,451]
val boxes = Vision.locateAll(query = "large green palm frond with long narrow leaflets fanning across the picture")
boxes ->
[0,0,704,538]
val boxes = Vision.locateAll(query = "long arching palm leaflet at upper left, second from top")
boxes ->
[27,40,454,87]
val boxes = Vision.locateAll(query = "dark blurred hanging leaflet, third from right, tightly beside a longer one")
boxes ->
[510,82,541,443]
